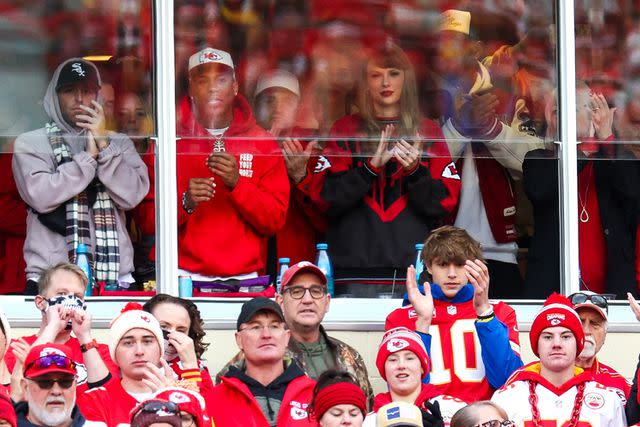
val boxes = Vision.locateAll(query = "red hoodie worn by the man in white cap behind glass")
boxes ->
[138,95,289,277]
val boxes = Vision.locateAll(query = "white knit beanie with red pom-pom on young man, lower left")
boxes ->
[109,302,164,364]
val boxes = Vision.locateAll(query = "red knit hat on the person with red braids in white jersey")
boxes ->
[529,292,584,356]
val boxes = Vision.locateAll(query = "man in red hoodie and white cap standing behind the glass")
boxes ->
[177,48,289,281]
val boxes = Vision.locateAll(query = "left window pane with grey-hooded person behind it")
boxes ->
[0,0,155,295]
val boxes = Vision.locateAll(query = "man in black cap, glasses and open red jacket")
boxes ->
[209,297,317,427]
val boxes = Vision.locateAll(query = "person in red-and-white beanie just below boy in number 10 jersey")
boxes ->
[364,327,466,427]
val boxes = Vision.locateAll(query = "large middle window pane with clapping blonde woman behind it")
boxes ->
[175,0,559,298]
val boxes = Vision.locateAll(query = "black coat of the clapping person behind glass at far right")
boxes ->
[522,149,640,298]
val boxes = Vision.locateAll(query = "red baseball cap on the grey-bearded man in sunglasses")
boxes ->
[23,343,77,378]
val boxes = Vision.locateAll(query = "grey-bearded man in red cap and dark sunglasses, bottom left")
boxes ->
[15,343,85,427]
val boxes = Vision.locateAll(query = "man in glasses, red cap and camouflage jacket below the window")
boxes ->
[216,261,373,405]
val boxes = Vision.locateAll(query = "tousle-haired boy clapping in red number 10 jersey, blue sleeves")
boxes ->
[385,226,522,403]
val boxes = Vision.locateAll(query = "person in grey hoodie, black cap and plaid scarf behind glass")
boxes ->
[12,58,149,293]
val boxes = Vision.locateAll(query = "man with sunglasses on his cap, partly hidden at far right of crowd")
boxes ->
[569,291,631,402]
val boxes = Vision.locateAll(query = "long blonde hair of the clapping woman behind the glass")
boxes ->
[358,42,422,138]
